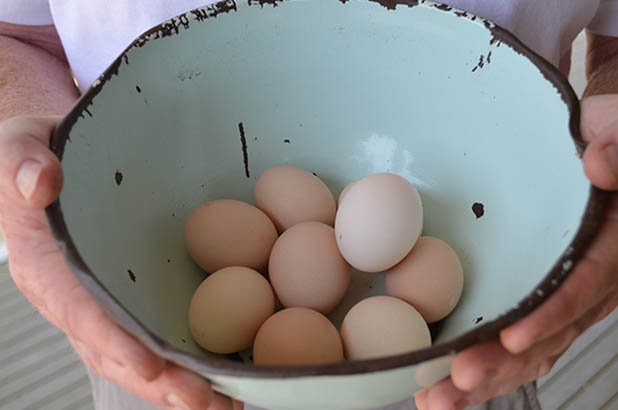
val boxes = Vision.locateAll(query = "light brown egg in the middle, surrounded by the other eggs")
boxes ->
[268,222,352,314]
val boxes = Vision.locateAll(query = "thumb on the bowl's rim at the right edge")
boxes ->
[584,120,618,191]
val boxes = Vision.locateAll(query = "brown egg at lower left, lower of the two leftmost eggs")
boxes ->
[189,266,275,354]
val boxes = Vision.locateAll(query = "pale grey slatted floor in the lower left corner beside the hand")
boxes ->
[0,266,94,410]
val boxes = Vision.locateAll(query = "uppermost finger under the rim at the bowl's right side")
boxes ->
[500,218,618,353]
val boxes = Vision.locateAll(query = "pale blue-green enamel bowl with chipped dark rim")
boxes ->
[48,0,606,410]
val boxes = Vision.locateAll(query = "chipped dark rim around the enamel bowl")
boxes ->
[46,0,609,378]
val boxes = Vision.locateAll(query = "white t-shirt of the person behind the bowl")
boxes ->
[0,0,618,91]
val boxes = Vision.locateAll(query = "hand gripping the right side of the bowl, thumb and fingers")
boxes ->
[415,94,618,410]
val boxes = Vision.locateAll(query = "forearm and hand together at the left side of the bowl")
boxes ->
[0,23,243,410]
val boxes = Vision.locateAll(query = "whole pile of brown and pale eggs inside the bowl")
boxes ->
[184,165,463,365]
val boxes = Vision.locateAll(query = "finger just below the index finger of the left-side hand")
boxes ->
[71,340,215,410]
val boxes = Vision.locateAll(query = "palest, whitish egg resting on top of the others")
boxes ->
[335,173,423,272]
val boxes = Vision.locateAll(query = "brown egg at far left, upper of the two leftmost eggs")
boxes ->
[184,199,278,272]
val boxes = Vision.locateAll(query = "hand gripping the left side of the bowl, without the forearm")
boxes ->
[0,117,242,410]
